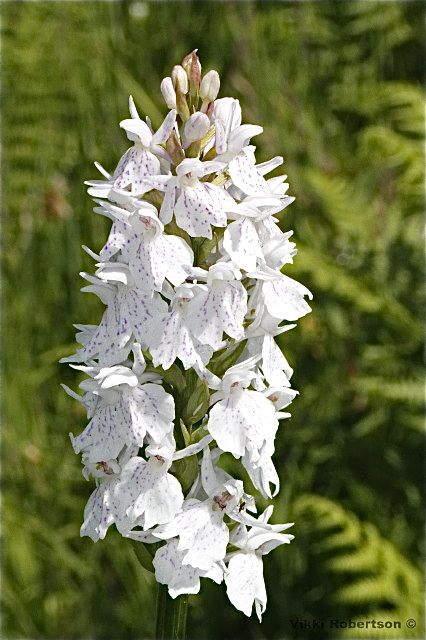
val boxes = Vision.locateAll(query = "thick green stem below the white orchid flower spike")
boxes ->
[155,584,188,640]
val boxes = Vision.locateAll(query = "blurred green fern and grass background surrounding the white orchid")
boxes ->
[1,1,424,640]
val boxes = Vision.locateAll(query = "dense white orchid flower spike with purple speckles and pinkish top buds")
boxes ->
[64,52,311,619]
